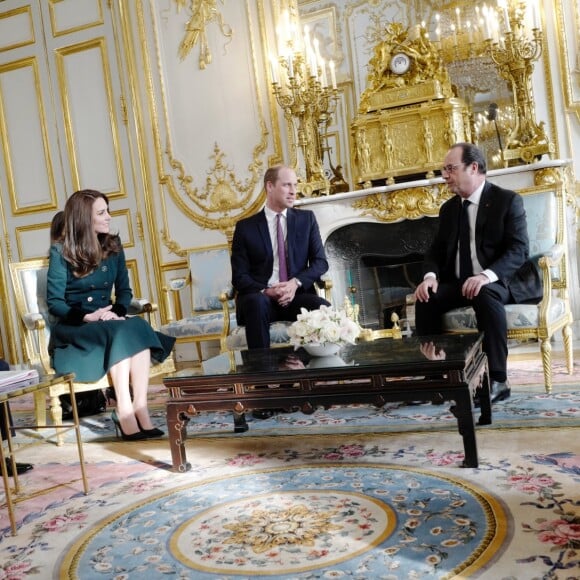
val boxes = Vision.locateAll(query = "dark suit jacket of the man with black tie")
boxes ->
[424,181,542,303]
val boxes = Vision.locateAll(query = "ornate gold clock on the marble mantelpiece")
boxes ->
[351,22,471,188]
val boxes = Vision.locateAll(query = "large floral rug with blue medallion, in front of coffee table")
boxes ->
[0,428,580,580]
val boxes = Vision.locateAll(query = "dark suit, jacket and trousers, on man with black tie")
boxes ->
[415,181,542,381]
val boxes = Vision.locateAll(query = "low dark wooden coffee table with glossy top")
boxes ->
[163,334,491,471]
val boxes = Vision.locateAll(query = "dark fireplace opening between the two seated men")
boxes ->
[325,217,438,329]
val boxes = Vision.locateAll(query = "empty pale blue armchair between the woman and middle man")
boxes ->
[161,245,236,361]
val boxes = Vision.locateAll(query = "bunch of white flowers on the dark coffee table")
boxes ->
[288,306,360,349]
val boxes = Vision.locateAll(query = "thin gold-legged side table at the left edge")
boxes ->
[0,373,89,536]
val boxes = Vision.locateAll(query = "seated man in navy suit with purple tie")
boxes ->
[232,165,329,349]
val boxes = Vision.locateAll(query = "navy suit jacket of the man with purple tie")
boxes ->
[231,209,328,294]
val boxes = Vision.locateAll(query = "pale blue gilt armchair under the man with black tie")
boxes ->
[444,183,574,393]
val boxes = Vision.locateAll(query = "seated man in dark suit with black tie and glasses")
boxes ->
[415,143,542,402]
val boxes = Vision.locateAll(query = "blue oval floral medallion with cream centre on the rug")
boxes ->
[61,463,508,579]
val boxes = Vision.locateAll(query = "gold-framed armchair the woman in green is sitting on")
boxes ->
[10,259,175,445]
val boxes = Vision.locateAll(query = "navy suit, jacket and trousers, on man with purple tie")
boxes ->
[232,209,328,348]
